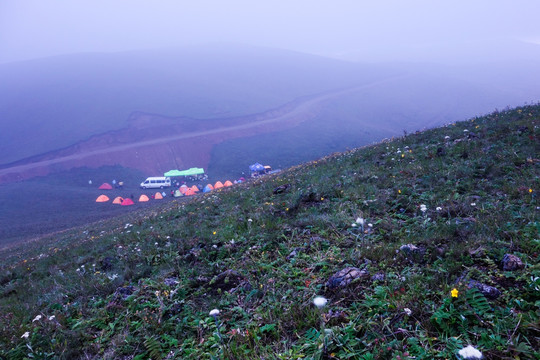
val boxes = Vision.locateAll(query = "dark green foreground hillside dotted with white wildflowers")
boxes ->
[0,106,540,359]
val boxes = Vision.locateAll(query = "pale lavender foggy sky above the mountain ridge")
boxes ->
[0,0,540,63]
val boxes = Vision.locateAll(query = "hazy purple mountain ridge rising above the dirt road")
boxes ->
[0,46,395,164]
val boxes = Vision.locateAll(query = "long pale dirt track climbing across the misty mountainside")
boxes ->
[0,75,408,177]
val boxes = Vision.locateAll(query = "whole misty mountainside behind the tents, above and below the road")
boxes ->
[0,45,540,181]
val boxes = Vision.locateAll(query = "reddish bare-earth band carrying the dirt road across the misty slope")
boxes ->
[0,77,401,183]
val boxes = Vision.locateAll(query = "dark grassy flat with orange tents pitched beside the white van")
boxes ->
[0,165,255,247]
